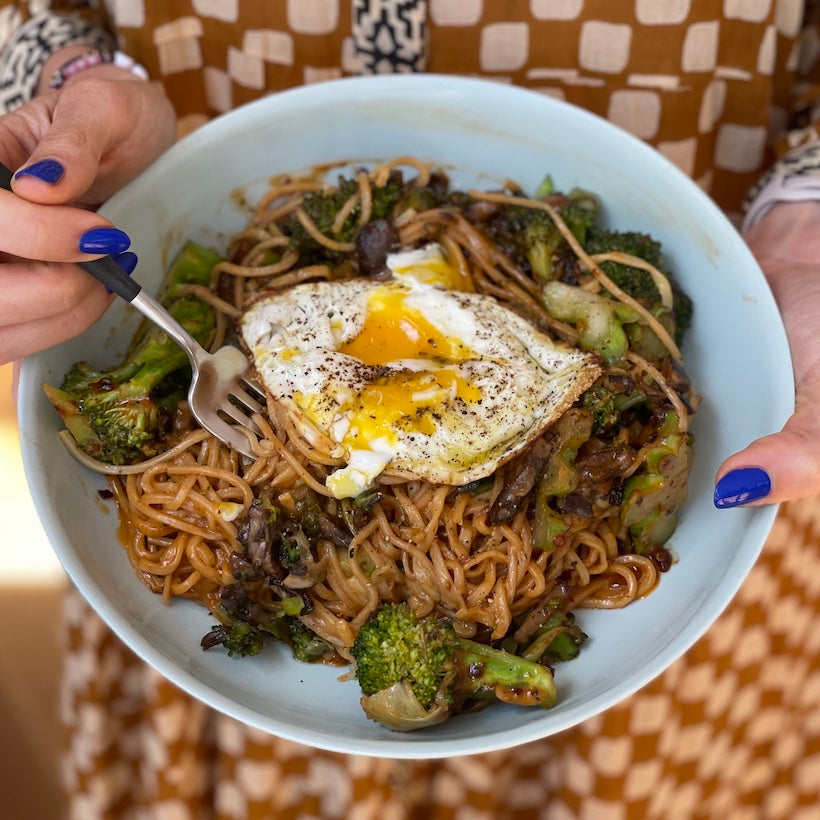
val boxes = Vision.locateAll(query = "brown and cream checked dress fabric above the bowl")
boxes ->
[110,0,816,211]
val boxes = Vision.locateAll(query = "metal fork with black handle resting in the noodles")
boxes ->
[0,163,265,457]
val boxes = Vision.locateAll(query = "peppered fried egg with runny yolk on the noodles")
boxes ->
[240,255,601,498]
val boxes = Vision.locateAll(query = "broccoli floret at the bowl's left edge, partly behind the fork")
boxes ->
[43,243,221,464]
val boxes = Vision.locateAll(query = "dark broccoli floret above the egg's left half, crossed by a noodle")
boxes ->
[287,177,402,262]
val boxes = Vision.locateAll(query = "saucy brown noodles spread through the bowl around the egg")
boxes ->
[96,157,689,684]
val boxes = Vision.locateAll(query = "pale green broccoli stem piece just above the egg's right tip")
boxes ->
[541,281,640,364]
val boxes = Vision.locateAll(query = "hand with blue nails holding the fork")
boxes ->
[0,59,175,364]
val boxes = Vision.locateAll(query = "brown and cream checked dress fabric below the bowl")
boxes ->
[62,500,820,820]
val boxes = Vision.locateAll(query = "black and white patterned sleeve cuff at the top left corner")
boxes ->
[0,11,116,114]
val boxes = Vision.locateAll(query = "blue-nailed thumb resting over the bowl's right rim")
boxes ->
[715,379,820,508]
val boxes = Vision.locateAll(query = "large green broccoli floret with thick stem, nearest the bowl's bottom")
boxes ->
[351,603,555,730]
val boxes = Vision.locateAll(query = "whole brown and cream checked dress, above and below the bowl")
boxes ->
[0,0,820,820]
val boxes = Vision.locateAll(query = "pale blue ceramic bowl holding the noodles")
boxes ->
[20,76,793,758]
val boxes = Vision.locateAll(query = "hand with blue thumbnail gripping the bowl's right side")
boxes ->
[715,202,820,507]
